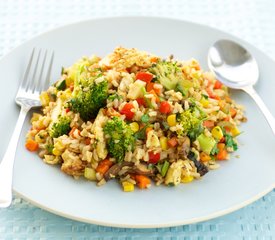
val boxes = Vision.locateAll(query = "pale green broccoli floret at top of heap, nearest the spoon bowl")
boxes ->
[149,60,183,90]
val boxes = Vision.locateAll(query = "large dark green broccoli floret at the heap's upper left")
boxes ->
[69,77,108,121]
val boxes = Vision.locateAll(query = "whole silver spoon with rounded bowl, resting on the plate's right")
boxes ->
[208,40,275,135]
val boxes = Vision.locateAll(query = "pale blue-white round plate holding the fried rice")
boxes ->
[0,17,275,228]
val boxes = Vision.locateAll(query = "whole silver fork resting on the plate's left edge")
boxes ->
[0,49,54,208]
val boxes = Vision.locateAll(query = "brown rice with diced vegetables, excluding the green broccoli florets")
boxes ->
[26,47,246,191]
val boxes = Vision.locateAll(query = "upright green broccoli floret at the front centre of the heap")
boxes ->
[103,117,135,162]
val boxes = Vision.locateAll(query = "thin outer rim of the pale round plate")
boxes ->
[0,15,275,228]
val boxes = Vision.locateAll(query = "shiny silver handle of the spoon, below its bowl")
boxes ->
[243,86,275,135]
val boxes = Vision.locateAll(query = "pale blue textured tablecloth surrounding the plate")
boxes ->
[0,0,275,240]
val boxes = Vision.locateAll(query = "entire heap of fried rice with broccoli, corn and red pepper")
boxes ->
[26,47,246,192]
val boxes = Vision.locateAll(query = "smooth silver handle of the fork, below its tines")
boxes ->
[0,106,30,208]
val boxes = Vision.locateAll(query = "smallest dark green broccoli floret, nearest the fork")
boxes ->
[49,116,71,138]
